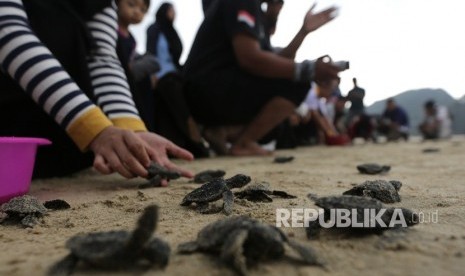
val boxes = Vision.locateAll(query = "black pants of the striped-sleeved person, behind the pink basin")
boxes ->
[0,94,93,178]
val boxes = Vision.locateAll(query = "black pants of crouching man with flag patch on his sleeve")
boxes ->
[186,68,310,126]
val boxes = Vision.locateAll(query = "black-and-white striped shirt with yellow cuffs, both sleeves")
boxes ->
[0,0,146,149]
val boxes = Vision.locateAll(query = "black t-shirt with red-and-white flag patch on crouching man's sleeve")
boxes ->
[184,0,271,80]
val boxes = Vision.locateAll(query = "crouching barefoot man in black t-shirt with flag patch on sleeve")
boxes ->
[184,0,339,156]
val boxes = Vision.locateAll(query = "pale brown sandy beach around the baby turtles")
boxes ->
[0,136,465,276]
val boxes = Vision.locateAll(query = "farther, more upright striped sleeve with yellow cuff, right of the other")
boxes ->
[87,3,147,131]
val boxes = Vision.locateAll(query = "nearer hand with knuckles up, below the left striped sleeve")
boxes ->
[89,126,150,178]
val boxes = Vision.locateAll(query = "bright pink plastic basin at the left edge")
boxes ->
[0,137,51,203]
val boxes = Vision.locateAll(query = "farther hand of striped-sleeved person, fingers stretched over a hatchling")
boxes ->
[136,132,194,186]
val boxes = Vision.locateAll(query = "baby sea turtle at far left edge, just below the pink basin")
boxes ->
[0,195,47,227]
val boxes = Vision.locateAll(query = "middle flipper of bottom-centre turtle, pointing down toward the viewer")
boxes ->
[220,229,248,275]
